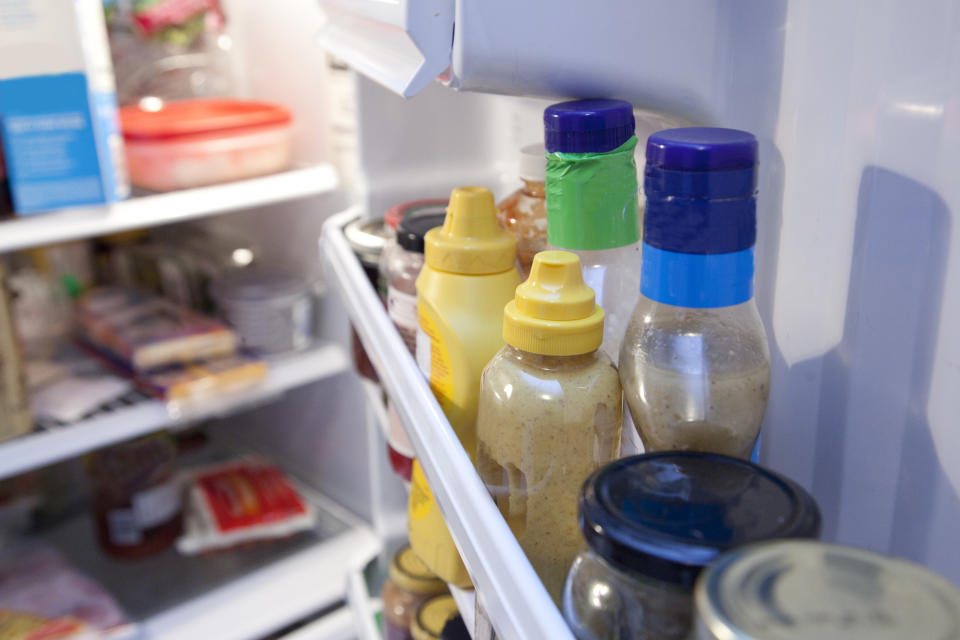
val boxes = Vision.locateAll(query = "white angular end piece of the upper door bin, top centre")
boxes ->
[317,0,454,98]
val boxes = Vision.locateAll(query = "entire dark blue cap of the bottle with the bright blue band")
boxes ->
[643,127,757,254]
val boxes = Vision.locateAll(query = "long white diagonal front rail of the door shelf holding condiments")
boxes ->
[321,209,573,640]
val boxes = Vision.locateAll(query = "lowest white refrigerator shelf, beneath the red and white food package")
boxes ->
[41,480,381,640]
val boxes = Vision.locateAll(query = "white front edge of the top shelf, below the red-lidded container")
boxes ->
[0,164,339,253]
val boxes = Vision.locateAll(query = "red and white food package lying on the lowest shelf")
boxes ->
[177,457,316,555]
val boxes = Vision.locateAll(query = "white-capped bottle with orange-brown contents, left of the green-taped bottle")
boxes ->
[497,143,547,278]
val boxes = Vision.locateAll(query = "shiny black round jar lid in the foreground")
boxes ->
[580,451,820,588]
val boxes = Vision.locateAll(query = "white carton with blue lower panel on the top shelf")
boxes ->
[0,0,130,215]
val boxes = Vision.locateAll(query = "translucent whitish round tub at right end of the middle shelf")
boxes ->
[212,269,313,355]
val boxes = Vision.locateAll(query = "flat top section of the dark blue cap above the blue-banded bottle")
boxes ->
[647,127,757,171]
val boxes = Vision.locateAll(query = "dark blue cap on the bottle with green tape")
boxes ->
[543,99,636,153]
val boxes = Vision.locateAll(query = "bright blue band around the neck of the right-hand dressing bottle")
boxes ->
[640,242,753,309]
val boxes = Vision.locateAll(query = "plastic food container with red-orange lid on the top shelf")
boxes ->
[120,99,291,191]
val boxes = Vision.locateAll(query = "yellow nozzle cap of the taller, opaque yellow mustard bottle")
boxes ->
[424,187,517,275]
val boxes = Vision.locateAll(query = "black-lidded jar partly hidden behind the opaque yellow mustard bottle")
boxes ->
[380,210,446,356]
